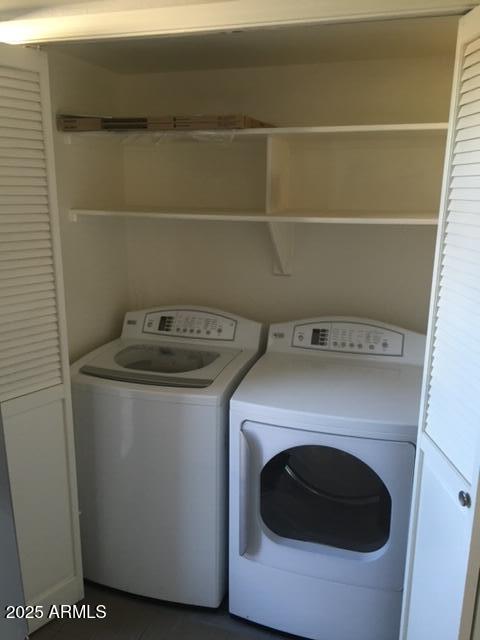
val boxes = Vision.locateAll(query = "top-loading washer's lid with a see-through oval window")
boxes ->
[80,340,244,388]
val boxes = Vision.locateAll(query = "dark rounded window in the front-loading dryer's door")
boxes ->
[260,445,392,552]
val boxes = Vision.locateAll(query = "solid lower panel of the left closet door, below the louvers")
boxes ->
[3,392,77,602]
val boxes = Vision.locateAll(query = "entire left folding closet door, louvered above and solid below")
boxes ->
[0,45,83,631]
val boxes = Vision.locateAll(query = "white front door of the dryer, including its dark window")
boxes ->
[241,422,415,589]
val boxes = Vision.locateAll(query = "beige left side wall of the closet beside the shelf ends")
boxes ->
[49,52,129,360]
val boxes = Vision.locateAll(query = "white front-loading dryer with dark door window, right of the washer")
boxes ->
[229,317,425,640]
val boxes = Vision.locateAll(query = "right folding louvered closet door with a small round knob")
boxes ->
[402,9,480,640]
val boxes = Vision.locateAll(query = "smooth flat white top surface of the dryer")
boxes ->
[232,352,422,426]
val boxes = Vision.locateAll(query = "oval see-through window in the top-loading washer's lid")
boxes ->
[115,344,219,373]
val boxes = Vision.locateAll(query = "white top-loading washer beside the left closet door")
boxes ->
[72,306,262,607]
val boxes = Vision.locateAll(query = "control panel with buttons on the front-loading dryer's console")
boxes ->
[292,322,405,356]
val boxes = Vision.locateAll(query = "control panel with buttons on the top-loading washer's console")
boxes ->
[143,309,237,340]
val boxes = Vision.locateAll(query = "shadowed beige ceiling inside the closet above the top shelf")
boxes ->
[45,16,458,74]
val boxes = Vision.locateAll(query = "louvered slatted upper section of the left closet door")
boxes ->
[0,60,62,401]
